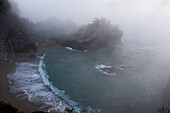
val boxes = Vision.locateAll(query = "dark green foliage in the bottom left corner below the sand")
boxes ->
[0,101,18,113]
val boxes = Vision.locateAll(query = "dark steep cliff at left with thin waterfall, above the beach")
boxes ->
[0,0,36,62]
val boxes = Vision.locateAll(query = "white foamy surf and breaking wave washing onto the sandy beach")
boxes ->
[8,55,81,112]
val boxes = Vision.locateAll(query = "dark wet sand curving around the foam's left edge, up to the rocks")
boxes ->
[0,55,38,113]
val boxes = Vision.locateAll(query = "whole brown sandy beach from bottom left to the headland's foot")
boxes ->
[0,41,60,113]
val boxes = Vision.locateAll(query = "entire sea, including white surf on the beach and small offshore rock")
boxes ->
[8,36,170,113]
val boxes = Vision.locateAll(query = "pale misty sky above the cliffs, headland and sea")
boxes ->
[12,0,170,42]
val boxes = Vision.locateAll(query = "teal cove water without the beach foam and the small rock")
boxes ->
[44,42,169,113]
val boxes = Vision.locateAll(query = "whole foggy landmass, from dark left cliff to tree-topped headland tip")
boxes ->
[0,0,123,61]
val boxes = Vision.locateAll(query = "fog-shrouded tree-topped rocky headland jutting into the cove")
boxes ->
[67,17,123,50]
